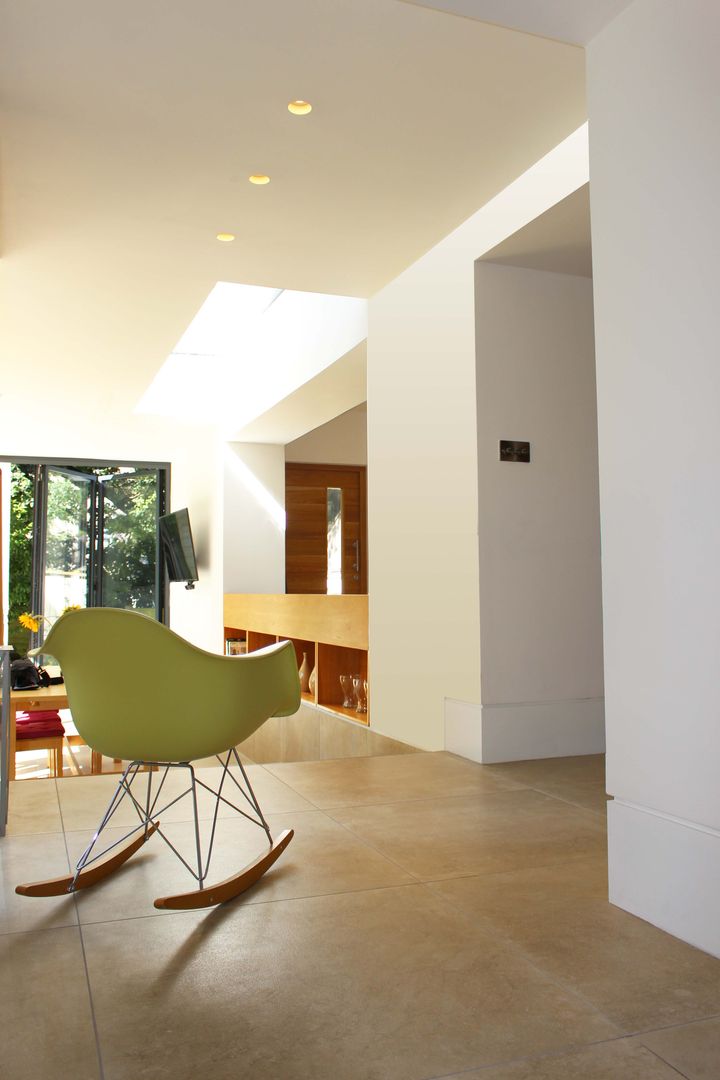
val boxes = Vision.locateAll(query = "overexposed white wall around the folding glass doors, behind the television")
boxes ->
[0,410,222,651]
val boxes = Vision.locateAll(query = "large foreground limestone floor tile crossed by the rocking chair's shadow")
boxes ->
[84,885,617,1080]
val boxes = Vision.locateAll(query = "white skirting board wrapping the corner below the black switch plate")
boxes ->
[445,698,604,765]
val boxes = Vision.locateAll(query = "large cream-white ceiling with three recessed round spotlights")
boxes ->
[0,0,587,438]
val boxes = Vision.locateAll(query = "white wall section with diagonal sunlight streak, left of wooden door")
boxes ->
[222,443,285,593]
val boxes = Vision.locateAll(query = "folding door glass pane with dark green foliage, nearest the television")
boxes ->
[99,469,158,618]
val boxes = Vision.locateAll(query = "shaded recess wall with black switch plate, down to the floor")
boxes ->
[475,262,603,761]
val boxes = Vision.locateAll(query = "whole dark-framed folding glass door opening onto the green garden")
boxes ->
[8,462,168,654]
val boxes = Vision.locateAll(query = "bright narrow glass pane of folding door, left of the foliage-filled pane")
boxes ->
[43,469,95,619]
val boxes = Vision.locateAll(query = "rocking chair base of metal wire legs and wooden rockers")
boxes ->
[15,747,293,908]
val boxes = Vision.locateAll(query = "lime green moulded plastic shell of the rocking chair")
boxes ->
[36,608,300,761]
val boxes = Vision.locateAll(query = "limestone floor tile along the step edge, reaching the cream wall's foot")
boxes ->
[263,753,520,809]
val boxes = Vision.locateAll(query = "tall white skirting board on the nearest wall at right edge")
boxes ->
[608,799,720,957]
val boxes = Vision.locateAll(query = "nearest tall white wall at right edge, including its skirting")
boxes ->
[588,0,720,955]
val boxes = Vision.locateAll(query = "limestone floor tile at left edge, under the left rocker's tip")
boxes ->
[0,833,78,934]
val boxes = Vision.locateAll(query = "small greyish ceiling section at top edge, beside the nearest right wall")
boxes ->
[405,0,633,45]
